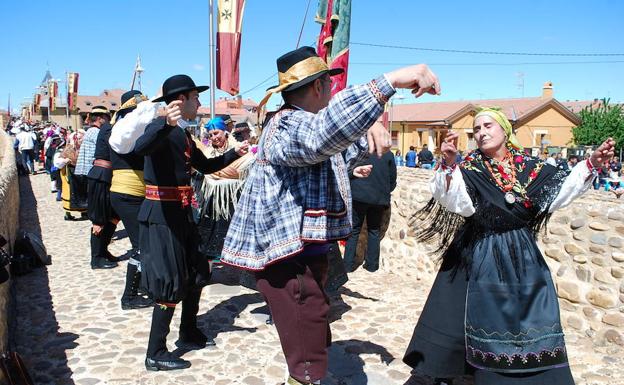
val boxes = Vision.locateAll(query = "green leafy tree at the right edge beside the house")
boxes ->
[572,98,624,148]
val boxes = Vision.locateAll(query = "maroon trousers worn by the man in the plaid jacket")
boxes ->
[256,254,331,383]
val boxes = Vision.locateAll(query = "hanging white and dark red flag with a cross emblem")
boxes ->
[217,0,245,95]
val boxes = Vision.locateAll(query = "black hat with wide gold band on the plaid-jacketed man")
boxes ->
[259,47,344,107]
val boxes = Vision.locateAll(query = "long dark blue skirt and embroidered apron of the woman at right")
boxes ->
[403,228,574,385]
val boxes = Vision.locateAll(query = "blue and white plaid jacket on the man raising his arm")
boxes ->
[222,76,395,270]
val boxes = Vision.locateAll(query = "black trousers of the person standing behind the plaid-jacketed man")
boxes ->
[344,201,385,272]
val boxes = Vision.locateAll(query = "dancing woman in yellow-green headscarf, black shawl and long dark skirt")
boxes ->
[403,108,615,385]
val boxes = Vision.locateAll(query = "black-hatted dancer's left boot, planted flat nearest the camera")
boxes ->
[145,304,191,371]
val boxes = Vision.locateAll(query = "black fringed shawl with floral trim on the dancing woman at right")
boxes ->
[410,149,568,279]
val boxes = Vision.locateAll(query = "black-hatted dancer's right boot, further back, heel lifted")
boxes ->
[175,289,216,350]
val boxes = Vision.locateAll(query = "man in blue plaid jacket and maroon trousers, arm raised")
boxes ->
[222,47,440,384]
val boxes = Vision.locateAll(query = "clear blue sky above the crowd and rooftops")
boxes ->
[0,0,624,109]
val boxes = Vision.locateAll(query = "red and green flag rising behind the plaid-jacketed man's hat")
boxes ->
[316,0,351,95]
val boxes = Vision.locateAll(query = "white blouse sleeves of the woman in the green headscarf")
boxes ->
[429,162,593,217]
